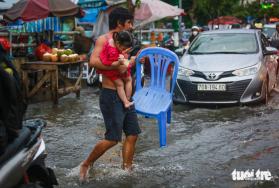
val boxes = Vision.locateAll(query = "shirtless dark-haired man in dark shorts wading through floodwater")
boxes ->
[79,8,141,181]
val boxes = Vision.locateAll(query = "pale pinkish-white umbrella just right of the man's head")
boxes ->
[135,0,185,26]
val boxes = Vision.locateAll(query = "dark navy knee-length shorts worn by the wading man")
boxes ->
[99,88,141,142]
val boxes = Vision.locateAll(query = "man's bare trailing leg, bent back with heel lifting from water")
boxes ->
[79,140,117,181]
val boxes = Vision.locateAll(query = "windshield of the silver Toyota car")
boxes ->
[188,33,258,54]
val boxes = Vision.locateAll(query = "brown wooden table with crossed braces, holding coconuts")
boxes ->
[21,61,84,105]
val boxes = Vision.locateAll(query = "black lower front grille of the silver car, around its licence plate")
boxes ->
[177,79,251,102]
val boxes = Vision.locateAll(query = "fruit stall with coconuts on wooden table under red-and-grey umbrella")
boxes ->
[2,0,84,104]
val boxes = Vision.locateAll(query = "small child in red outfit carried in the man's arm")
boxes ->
[99,31,135,108]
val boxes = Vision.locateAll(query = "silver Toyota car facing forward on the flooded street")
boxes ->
[174,29,278,104]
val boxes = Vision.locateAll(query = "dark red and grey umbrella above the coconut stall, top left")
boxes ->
[3,0,84,22]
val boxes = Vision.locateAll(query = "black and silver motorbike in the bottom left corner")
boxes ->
[0,119,58,188]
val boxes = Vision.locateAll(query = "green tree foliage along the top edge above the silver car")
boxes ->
[163,0,279,25]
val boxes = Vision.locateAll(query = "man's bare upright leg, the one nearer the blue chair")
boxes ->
[122,135,138,170]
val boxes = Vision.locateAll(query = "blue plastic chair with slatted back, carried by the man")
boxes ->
[133,47,179,147]
